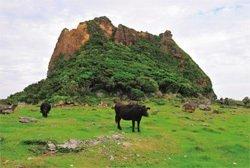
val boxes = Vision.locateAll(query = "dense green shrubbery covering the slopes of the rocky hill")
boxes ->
[8,17,214,103]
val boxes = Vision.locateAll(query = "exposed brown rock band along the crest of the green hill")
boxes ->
[48,16,214,97]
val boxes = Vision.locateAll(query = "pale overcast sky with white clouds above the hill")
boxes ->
[0,0,250,99]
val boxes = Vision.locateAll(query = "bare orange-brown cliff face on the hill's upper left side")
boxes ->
[49,22,90,71]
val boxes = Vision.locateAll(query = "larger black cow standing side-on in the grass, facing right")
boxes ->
[115,103,150,132]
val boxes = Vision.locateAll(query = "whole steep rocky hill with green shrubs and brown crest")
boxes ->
[8,16,215,103]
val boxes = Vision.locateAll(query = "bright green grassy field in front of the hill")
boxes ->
[0,100,250,168]
